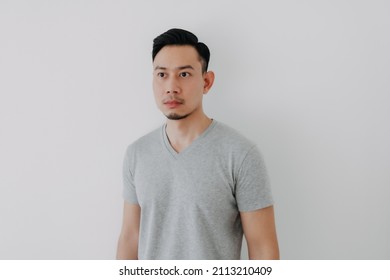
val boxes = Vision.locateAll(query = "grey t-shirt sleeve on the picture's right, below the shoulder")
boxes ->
[235,146,274,212]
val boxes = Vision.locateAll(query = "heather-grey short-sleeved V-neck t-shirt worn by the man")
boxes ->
[123,120,273,260]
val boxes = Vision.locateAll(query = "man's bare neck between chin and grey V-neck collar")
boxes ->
[166,111,212,153]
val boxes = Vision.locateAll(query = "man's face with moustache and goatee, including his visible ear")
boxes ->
[153,46,212,120]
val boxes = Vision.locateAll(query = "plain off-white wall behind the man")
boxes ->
[0,0,390,259]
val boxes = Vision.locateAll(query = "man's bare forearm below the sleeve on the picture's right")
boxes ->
[240,206,279,260]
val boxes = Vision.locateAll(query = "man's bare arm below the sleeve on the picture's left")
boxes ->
[116,202,141,260]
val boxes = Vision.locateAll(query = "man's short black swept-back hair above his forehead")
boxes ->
[152,28,210,73]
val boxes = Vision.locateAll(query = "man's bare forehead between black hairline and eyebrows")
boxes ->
[153,46,201,68]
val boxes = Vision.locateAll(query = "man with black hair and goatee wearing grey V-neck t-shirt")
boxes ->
[117,29,279,259]
